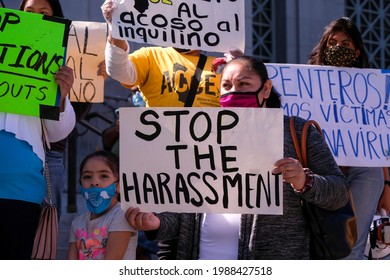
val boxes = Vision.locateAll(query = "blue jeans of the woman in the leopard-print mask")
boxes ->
[345,167,384,260]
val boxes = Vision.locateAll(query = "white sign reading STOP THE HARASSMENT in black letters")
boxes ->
[119,107,283,215]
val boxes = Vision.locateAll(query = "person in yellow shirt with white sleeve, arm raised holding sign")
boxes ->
[102,0,240,107]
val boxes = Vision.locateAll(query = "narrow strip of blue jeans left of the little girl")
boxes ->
[46,150,65,220]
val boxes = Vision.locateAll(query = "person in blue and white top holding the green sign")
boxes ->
[0,1,75,260]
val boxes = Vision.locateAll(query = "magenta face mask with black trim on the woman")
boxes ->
[219,83,265,108]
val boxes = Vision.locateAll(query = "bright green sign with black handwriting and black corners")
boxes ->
[0,9,70,119]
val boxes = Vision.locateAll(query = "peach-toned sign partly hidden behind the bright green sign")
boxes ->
[66,21,107,103]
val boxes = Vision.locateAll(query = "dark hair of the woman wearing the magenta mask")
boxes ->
[222,55,282,108]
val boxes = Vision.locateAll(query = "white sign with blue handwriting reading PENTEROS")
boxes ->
[267,64,390,167]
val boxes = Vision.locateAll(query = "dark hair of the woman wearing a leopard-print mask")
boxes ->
[308,17,368,68]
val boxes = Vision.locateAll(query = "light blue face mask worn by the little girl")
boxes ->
[81,183,116,214]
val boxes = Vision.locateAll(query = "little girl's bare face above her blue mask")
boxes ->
[80,157,118,189]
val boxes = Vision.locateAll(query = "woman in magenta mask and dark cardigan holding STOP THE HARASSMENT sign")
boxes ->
[126,56,349,260]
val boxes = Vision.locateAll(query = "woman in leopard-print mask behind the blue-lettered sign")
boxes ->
[308,17,390,260]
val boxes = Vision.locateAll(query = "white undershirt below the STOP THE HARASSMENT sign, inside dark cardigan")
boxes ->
[199,213,241,260]
